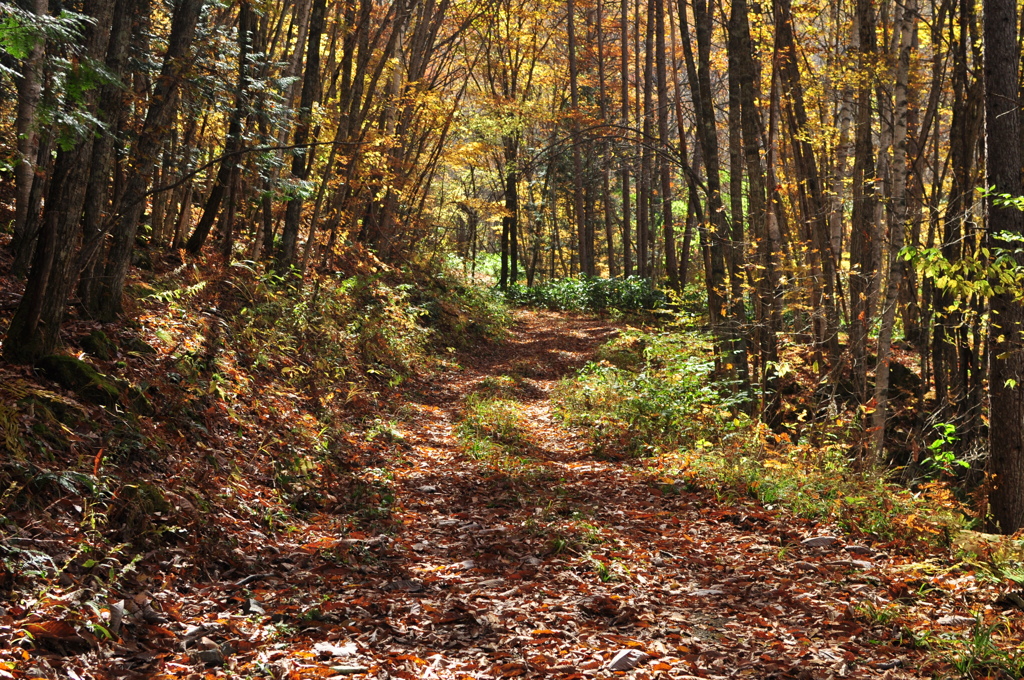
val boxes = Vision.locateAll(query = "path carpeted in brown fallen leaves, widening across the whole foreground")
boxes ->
[6,311,1015,680]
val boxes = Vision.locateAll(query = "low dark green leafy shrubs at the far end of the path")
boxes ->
[505,277,668,311]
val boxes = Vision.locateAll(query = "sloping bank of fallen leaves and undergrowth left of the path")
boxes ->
[0,255,510,592]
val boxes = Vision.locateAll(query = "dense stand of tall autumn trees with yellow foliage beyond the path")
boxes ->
[0,0,1024,533]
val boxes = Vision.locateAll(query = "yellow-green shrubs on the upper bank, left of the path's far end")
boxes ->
[230,262,510,389]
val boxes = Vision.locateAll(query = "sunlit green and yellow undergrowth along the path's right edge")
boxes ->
[554,328,968,544]
